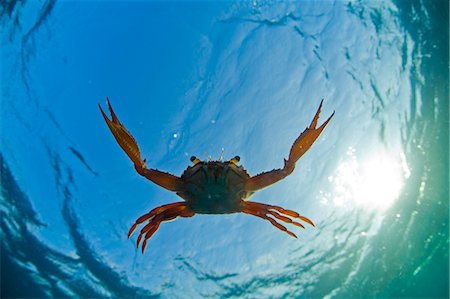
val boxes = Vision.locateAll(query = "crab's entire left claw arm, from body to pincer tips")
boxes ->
[98,97,183,191]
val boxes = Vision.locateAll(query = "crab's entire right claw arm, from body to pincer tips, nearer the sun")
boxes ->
[245,100,334,192]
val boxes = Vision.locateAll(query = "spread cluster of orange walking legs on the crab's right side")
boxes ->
[242,201,314,238]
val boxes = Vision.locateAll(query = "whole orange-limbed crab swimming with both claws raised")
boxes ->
[98,97,334,253]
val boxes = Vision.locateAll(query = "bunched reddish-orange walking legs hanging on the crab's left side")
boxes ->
[128,202,194,253]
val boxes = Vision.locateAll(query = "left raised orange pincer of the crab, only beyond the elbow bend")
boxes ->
[98,97,145,169]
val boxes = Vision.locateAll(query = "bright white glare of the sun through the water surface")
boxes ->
[321,148,408,210]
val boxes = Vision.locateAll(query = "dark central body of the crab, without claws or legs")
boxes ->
[177,161,252,214]
